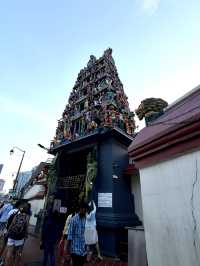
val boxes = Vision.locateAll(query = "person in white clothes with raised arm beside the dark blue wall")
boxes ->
[85,201,102,260]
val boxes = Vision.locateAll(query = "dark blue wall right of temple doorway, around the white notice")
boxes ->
[93,136,139,257]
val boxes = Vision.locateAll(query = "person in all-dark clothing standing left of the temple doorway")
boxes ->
[41,211,62,266]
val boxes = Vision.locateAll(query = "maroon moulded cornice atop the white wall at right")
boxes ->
[129,115,200,168]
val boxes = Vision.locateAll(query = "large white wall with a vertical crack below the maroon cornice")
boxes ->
[140,151,200,266]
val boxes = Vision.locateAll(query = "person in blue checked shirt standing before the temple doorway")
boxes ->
[66,202,88,266]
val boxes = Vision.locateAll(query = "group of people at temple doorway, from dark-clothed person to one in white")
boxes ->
[41,201,102,266]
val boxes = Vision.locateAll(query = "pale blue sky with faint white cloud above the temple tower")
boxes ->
[0,0,200,189]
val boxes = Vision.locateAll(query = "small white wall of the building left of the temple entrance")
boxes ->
[24,185,45,225]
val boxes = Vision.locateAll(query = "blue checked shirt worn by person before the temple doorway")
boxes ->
[67,214,86,256]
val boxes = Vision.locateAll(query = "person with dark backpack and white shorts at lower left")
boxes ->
[5,203,29,266]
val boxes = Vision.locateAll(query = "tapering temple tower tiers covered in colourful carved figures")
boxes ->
[51,49,135,147]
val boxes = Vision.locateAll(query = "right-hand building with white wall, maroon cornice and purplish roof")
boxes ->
[129,87,200,266]
